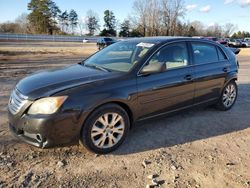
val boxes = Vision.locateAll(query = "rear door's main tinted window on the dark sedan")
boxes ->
[192,42,218,64]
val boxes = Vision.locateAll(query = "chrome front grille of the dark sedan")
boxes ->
[9,89,28,114]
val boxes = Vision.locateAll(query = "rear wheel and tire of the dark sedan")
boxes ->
[217,80,238,111]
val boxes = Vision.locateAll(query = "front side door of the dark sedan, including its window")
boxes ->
[137,42,194,118]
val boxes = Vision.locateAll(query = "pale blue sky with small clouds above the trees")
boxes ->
[0,0,250,32]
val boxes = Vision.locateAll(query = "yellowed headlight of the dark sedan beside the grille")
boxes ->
[28,96,68,115]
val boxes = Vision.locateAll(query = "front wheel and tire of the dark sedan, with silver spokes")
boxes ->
[80,104,130,154]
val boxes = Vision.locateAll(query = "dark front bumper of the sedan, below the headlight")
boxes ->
[9,112,83,148]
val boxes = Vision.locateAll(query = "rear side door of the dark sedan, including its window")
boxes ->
[191,42,230,104]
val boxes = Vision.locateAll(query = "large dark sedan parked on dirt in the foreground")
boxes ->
[8,37,238,154]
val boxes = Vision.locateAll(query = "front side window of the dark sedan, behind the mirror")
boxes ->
[149,42,188,70]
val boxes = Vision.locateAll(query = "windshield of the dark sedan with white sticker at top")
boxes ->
[84,41,154,72]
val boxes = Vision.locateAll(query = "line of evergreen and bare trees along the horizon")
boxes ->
[0,0,250,38]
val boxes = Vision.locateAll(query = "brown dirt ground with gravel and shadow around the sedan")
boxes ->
[0,42,250,188]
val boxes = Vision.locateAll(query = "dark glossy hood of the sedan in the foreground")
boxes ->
[16,64,119,100]
